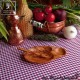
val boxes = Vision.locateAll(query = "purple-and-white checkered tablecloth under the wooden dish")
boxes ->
[0,35,80,80]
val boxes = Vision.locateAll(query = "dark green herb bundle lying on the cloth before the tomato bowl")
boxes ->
[29,34,58,41]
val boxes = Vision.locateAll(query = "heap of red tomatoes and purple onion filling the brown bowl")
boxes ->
[33,5,66,23]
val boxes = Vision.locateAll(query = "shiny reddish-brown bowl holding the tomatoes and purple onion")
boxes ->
[37,20,65,33]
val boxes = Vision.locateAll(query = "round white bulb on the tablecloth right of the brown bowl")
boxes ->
[62,26,77,39]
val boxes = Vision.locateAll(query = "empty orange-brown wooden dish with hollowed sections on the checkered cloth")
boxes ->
[20,46,66,64]
